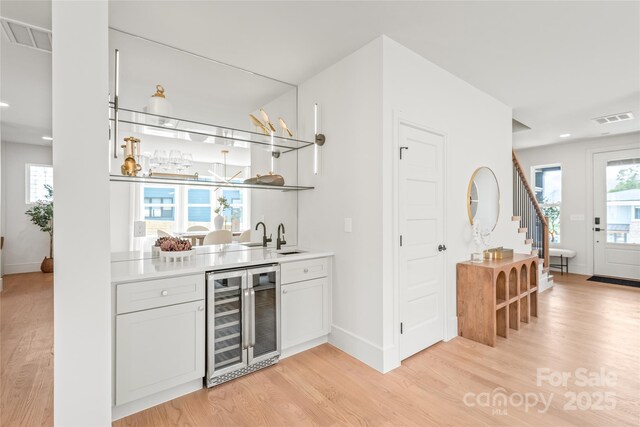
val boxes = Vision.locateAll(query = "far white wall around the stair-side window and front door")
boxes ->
[516,132,640,274]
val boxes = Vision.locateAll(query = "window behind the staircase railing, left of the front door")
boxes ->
[533,165,562,243]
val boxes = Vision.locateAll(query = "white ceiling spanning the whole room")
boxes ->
[0,0,640,148]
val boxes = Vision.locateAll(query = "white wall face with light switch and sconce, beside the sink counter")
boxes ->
[298,38,383,368]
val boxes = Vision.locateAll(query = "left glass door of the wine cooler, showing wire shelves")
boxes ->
[207,270,249,378]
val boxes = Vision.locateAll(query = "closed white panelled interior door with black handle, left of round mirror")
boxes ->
[399,124,445,360]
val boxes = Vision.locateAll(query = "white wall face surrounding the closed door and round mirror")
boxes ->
[383,37,523,370]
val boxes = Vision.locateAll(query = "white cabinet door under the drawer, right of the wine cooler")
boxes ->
[281,277,329,349]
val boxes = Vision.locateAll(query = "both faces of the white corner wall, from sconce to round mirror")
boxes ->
[299,36,516,371]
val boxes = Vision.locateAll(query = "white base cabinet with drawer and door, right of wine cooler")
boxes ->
[280,258,331,351]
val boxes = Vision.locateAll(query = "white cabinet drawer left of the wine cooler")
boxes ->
[116,274,204,314]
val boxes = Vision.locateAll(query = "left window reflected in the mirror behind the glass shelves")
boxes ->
[143,187,177,235]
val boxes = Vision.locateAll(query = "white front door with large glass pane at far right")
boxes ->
[593,149,640,280]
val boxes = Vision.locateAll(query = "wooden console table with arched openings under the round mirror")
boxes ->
[456,254,538,347]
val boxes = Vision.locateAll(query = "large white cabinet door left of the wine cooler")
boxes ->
[116,301,205,405]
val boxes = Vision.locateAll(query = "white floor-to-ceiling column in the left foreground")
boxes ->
[52,0,111,426]
